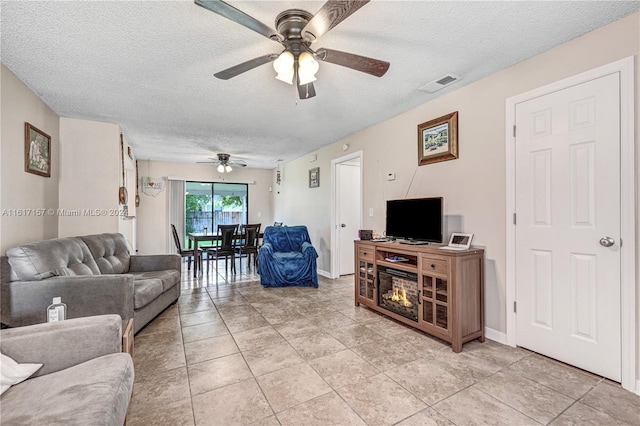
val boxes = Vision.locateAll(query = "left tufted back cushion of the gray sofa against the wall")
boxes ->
[7,238,100,281]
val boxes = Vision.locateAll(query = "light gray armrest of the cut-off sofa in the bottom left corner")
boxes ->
[0,315,122,377]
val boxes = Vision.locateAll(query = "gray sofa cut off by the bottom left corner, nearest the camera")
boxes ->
[0,315,134,426]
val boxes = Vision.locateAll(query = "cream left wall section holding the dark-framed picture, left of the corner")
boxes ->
[0,65,60,251]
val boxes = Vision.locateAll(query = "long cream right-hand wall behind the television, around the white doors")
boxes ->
[274,13,640,342]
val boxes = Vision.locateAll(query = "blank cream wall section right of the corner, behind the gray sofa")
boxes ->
[58,118,122,237]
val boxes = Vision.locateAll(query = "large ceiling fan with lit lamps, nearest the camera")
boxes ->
[195,0,389,99]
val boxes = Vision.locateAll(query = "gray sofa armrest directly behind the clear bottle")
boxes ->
[1,274,133,327]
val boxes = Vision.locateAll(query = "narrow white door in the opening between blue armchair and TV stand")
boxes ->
[336,158,361,275]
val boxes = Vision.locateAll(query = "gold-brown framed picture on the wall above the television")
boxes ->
[418,111,458,166]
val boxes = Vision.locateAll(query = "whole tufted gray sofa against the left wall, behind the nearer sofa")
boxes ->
[0,234,181,333]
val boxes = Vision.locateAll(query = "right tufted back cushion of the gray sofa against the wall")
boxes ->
[78,234,130,274]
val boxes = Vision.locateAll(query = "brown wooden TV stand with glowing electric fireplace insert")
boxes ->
[354,240,484,352]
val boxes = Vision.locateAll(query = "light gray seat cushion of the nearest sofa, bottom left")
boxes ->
[2,353,134,426]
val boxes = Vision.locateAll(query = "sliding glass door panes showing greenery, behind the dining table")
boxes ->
[185,182,249,240]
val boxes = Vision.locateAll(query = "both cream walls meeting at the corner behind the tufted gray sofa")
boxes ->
[0,65,135,250]
